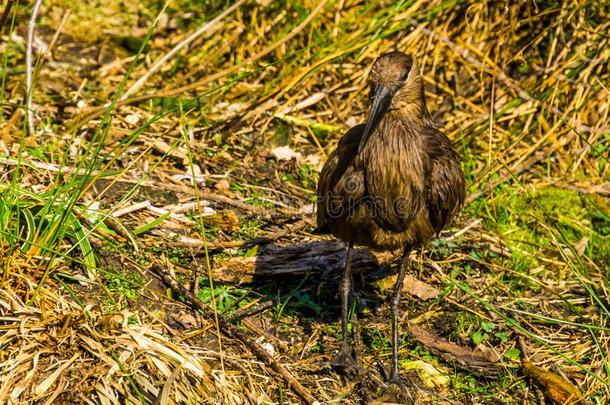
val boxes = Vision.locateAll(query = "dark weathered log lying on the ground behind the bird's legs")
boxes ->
[212,240,379,284]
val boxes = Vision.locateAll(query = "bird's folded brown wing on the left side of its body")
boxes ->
[317,124,364,232]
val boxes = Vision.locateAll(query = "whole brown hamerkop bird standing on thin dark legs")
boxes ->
[317,52,465,382]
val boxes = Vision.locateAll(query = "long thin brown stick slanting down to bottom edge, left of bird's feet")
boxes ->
[150,264,318,404]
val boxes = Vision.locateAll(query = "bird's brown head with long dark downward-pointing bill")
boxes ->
[359,51,427,150]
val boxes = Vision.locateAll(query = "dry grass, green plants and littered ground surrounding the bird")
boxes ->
[0,0,610,404]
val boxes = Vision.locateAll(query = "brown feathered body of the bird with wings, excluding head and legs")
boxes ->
[317,86,465,250]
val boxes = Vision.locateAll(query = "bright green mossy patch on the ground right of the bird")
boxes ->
[470,187,610,272]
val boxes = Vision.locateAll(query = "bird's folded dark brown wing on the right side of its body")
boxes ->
[425,127,466,234]
